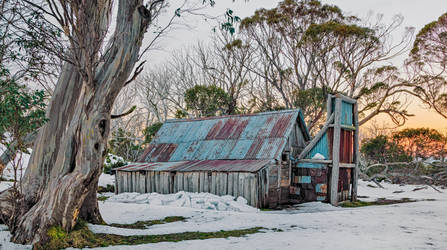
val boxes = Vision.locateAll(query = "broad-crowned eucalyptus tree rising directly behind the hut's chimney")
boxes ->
[241,0,412,129]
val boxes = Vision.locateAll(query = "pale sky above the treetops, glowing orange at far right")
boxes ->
[146,0,447,131]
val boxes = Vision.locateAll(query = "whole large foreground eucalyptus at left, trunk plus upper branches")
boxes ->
[0,0,231,243]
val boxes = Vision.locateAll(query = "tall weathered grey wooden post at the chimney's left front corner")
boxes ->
[330,95,342,206]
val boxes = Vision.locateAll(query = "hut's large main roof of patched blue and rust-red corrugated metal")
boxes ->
[140,109,308,162]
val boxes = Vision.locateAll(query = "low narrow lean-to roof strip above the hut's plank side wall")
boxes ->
[114,160,271,172]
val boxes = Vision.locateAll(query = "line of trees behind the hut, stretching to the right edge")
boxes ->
[106,0,447,164]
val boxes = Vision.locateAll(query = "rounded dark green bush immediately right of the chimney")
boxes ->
[360,135,411,163]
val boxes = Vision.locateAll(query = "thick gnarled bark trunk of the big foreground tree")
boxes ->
[0,0,151,244]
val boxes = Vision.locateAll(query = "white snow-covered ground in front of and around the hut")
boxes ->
[0,176,447,249]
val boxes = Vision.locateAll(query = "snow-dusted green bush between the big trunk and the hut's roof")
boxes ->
[109,128,143,161]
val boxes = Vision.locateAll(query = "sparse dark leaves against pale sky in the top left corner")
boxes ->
[0,1,63,84]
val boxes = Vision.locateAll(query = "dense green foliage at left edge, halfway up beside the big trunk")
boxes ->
[0,69,47,147]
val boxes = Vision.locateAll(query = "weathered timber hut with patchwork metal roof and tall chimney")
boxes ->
[115,95,358,208]
